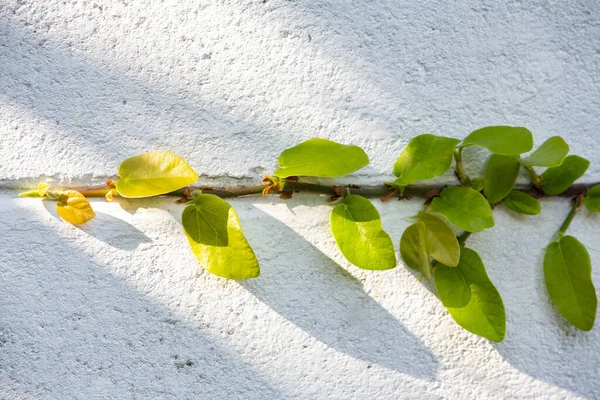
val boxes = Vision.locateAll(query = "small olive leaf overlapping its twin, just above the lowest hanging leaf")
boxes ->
[419,211,460,267]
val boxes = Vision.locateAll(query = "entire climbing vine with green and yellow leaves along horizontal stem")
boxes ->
[20,126,600,342]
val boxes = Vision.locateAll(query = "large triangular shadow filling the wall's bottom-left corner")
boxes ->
[0,204,285,399]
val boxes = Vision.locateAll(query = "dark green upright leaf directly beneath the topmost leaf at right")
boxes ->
[483,154,521,204]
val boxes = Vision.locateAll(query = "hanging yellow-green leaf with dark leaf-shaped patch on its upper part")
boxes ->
[181,194,260,279]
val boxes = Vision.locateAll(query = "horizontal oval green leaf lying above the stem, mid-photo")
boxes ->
[274,139,369,178]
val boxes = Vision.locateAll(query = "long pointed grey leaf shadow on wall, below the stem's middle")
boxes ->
[240,203,438,380]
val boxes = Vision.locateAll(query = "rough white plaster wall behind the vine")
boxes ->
[0,0,600,399]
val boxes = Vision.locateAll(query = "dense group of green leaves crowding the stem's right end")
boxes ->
[394,126,600,341]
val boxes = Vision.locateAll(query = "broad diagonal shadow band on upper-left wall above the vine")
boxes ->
[0,16,296,178]
